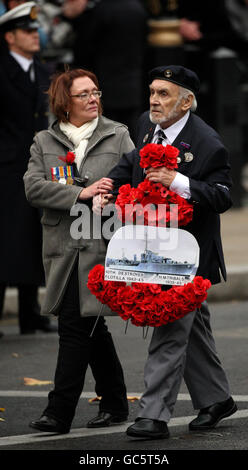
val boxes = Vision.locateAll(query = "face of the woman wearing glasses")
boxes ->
[69,77,100,127]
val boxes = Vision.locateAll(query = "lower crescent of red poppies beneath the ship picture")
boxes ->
[87,264,211,326]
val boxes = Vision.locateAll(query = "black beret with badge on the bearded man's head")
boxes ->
[149,65,200,94]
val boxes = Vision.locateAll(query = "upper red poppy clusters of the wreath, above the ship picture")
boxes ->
[115,144,193,227]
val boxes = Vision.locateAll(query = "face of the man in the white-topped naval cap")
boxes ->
[5,29,40,59]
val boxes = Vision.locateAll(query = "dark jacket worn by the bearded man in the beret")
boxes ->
[108,113,232,284]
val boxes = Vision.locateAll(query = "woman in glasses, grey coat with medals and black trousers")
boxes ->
[24,69,134,433]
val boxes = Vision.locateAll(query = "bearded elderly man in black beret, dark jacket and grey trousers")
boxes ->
[95,65,237,439]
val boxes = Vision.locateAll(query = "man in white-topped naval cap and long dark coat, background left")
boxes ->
[0,2,54,334]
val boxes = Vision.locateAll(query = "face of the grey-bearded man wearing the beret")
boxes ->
[150,79,185,128]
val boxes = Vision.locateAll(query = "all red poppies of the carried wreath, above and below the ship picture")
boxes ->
[87,144,211,327]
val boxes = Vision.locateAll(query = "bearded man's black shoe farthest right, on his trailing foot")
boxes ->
[189,397,238,431]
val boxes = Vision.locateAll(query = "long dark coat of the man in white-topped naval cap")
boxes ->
[0,52,49,285]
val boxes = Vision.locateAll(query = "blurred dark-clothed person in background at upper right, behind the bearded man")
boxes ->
[180,0,248,208]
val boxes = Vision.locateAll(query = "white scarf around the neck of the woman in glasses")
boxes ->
[59,117,98,170]
